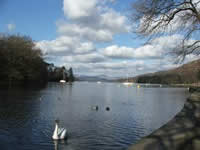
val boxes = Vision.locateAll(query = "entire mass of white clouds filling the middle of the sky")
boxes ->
[36,0,199,76]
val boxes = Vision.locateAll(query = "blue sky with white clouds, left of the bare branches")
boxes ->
[0,0,198,77]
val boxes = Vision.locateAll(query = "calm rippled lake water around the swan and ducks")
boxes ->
[0,82,187,150]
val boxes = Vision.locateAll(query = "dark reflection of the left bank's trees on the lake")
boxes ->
[0,88,45,128]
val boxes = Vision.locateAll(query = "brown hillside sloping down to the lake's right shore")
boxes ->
[120,59,200,84]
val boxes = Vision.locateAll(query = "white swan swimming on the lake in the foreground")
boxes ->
[52,120,67,140]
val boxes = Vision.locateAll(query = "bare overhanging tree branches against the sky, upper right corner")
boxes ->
[131,0,200,61]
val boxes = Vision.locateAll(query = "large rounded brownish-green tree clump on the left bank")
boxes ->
[0,35,47,84]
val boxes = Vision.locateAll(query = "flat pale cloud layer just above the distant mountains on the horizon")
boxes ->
[65,61,146,77]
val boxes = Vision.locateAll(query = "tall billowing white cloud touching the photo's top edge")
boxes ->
[57,0,131,42]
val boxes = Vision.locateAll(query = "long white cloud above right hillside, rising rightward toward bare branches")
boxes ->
[101,35,182,59]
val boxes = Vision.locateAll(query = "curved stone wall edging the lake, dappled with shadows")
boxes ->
[128,88,200,150]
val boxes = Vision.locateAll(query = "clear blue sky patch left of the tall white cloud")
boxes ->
[0,0,63,41]
